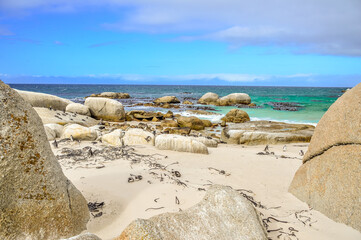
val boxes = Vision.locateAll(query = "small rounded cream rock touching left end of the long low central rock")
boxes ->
[123,128,154,146]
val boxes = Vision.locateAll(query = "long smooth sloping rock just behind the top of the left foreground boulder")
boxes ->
[16,90,73,111]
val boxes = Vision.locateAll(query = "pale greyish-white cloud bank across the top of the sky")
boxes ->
[0,0,361,57]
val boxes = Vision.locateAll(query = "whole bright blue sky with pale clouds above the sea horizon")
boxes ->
[0,0,361,87]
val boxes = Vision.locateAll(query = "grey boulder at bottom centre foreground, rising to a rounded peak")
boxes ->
[115,185,267,240]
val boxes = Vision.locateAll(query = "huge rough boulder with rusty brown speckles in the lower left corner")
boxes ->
[0,81,89,240]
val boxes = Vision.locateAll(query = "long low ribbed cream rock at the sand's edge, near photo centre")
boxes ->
[155,134,208,154]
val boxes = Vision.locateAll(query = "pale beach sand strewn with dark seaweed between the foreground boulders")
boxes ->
[57,143,361,240]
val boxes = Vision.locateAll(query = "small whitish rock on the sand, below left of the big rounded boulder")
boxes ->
[61,124,98,141]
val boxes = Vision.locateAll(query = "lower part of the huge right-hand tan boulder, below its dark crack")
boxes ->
[289,143,361,231]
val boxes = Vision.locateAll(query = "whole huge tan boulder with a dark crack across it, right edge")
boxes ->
[289,84,361,231]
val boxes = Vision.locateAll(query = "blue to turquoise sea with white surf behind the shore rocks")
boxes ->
[10,84,346,125]
